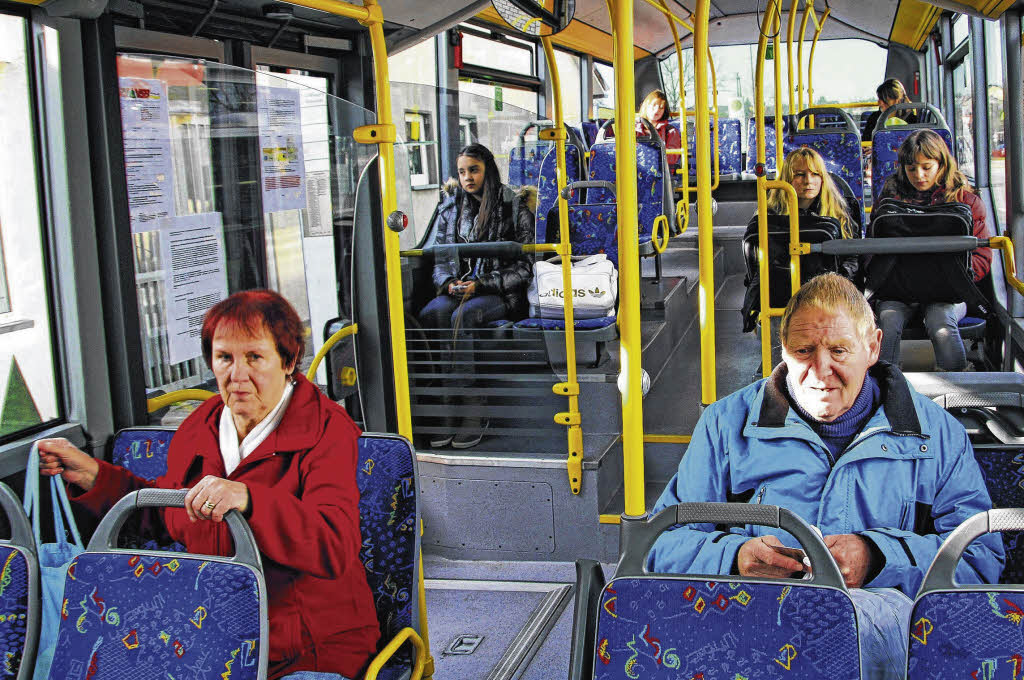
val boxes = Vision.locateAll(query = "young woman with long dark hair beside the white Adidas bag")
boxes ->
[419,144,537,449]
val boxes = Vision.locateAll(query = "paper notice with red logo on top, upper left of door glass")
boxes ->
[119,78,174,232]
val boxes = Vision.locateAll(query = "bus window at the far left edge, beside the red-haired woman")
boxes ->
[0,14,60,440]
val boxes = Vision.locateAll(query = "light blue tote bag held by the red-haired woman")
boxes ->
[25,444,85,680]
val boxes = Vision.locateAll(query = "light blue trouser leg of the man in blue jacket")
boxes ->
[850,588,913,680]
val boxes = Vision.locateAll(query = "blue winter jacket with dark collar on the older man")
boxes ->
[648,363,1005,597]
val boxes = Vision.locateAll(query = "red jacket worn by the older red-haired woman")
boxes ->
[75,376,380,678]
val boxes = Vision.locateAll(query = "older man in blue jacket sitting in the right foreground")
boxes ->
[649,273,1005,678]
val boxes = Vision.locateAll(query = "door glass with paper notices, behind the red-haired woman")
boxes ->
[118,54,376,413]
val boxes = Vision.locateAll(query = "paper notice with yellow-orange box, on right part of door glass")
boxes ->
[256,87,306,213]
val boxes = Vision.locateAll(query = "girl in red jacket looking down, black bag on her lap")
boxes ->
[876,129,992,371]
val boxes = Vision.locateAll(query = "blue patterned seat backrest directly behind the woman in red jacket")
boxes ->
[355,432,420,668]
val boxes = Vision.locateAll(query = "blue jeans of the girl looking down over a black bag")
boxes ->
[878,300,967,371]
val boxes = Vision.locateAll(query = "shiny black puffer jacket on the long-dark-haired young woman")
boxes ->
[433,182,537,315]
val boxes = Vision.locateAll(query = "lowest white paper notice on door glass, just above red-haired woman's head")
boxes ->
[160,213,227,364]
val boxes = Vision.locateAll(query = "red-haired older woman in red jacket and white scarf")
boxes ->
[39,291,379,680]
